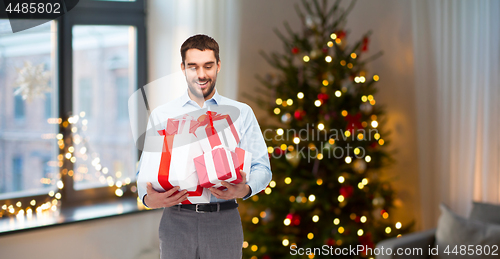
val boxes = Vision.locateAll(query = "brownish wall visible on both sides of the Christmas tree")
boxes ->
[238,0,420,230]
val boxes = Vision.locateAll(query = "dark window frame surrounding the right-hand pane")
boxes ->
[0,0,147,208]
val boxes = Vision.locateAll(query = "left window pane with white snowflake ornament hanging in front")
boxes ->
[0,19,59,200]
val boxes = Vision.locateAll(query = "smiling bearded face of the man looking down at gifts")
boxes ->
[181,49,220,99]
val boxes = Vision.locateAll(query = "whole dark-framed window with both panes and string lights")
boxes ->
[0,0,146,217]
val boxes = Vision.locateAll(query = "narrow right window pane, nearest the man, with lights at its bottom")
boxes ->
[72,25,137,190]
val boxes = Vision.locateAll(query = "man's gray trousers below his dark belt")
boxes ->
[159,207,243,259]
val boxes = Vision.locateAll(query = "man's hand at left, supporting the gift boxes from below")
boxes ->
[144,183,189,209]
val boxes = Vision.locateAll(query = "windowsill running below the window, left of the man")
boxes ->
[0,197,157,236]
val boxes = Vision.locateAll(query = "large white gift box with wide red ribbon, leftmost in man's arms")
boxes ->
[137,116,211,204]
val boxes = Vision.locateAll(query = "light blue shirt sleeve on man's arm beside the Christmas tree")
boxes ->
[240,107,272,199]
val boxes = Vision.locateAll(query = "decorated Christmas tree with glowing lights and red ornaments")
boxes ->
[242,0,412,259]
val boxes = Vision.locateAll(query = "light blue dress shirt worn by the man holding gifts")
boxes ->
[138,90,272,203]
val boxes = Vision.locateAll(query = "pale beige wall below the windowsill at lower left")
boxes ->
[0,210,162,259]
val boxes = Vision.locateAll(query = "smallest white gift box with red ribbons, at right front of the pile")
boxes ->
[194,145,252,189]
